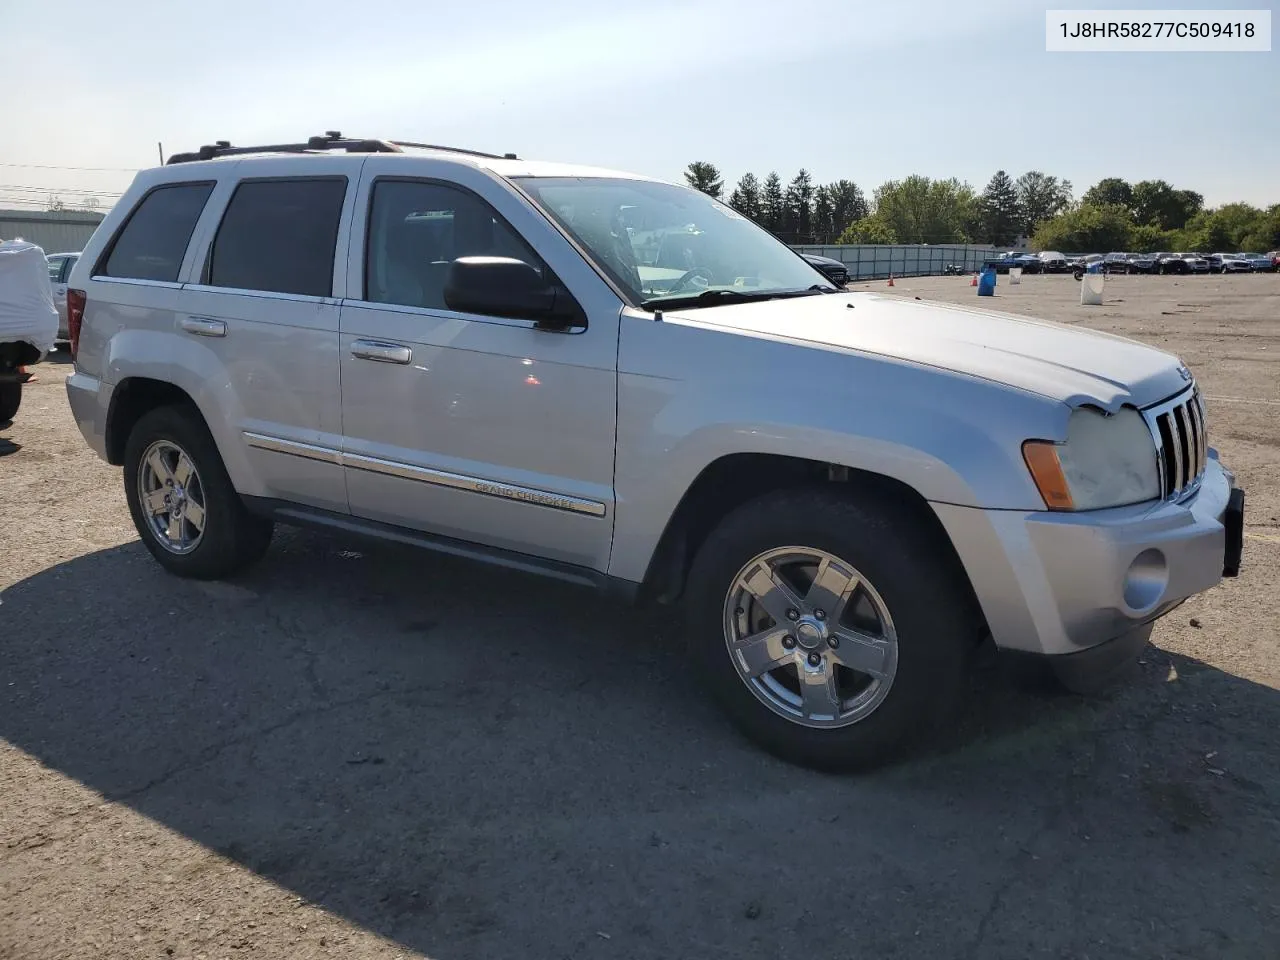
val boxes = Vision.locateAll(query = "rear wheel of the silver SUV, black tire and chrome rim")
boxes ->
[124,407,273,580]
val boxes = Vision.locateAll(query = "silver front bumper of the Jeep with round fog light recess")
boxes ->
[933,451,1244,657]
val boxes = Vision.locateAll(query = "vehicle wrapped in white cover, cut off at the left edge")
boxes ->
[0,239,58,424]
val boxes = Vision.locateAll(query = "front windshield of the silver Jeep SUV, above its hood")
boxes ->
[520,177,835,306]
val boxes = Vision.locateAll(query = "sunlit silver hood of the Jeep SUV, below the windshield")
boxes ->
[666,293,1190,412]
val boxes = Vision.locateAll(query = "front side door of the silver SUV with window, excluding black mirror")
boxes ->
[339,156,621,571]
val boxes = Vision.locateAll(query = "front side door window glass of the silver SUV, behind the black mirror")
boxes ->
[365,180,547,310]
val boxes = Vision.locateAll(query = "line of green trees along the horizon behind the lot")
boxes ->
[685,160,1280,252]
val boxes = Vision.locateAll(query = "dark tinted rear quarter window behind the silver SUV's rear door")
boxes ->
[101,183,214,283]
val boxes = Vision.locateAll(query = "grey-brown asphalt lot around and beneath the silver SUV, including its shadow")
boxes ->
[0,275,1280,960]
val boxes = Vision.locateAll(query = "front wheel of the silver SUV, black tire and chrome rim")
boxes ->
[685,488,980,771]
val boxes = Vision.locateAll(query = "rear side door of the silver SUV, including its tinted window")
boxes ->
[177,156,362,512]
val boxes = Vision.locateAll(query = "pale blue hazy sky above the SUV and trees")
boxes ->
[0,0,1280,209]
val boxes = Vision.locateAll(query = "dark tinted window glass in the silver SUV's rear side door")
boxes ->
[207,178,347,297]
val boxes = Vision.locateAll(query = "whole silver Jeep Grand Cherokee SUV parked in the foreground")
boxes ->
[67,133,1243,768]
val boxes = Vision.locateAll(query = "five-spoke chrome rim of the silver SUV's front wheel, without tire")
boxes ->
[723,547,897,728]
